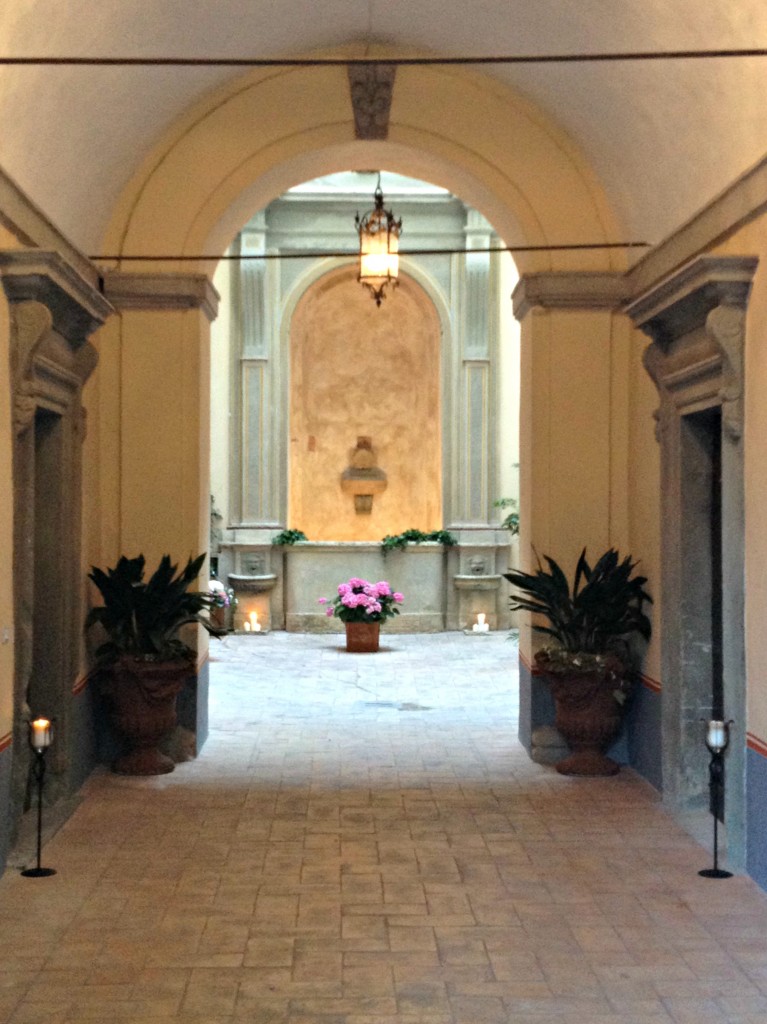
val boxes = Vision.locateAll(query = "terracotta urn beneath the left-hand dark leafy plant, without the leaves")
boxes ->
[104,656,191,775]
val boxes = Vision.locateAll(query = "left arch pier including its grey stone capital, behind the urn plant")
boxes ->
[100,272,218,756]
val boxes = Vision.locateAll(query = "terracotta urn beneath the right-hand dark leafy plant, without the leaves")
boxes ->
[548,672,624,775]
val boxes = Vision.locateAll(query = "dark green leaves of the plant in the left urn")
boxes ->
[85,552,222,668]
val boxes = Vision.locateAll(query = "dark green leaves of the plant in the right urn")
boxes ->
[504,548,652,673]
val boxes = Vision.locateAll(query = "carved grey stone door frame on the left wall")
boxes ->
[0,250,112,828]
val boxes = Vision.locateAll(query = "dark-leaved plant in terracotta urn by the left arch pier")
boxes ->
[85,553,220,775]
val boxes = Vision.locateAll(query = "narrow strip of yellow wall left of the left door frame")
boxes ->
[0,287,14,743]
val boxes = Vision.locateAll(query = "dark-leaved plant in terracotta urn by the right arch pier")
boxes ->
[504,548,652,775]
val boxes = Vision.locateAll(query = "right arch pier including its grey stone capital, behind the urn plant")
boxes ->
[512,271,628,750]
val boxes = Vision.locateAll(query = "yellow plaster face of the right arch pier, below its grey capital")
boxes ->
[520,308,631,658]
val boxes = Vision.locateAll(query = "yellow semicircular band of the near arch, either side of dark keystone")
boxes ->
[103,46,625,270]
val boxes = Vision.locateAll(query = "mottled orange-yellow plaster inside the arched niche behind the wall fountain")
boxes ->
[289,268,442,541]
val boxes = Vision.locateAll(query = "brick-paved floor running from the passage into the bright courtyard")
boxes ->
[0,633,767,1024]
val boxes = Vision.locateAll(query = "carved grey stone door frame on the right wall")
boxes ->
[627,256,758,867]
